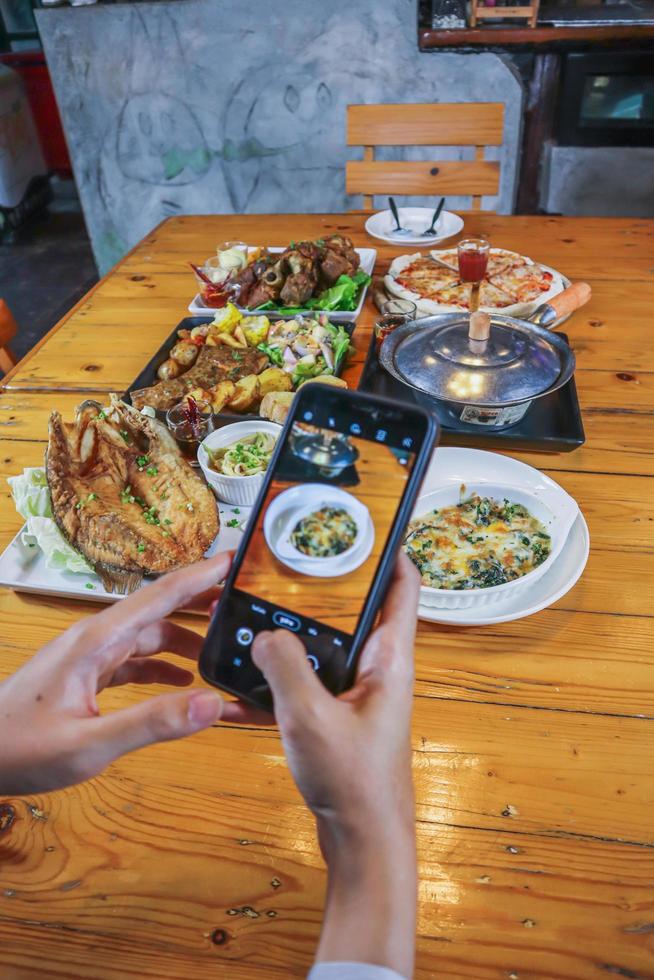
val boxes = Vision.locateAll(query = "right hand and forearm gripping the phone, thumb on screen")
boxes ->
[223,554,420,976]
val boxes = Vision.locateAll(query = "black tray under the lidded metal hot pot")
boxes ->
[359,331,586,453]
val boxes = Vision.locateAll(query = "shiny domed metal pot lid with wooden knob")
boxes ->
[380,313,574,405]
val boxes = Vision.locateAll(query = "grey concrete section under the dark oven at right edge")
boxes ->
[541,146,654,218]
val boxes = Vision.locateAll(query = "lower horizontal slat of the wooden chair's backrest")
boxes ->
[345,160,500,195]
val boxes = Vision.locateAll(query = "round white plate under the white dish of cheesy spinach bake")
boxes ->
[418,446,590,626]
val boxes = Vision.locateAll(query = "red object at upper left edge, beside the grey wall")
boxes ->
[0,51,72,177]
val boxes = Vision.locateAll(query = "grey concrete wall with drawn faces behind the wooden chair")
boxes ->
[37,0,522,271]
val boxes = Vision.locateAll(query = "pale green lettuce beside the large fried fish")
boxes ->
[7,466,93,575]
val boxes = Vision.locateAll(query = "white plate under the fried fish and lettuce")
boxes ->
[0,501,252,602]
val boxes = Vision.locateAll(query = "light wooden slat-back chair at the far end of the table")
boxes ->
[345,102,504,211]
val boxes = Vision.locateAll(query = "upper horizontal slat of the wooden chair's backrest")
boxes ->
[347,102,504,146]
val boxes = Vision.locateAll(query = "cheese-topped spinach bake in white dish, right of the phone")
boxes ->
[404,494,552,591]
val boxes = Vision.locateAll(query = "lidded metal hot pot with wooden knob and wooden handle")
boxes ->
[379,283,590,429]
